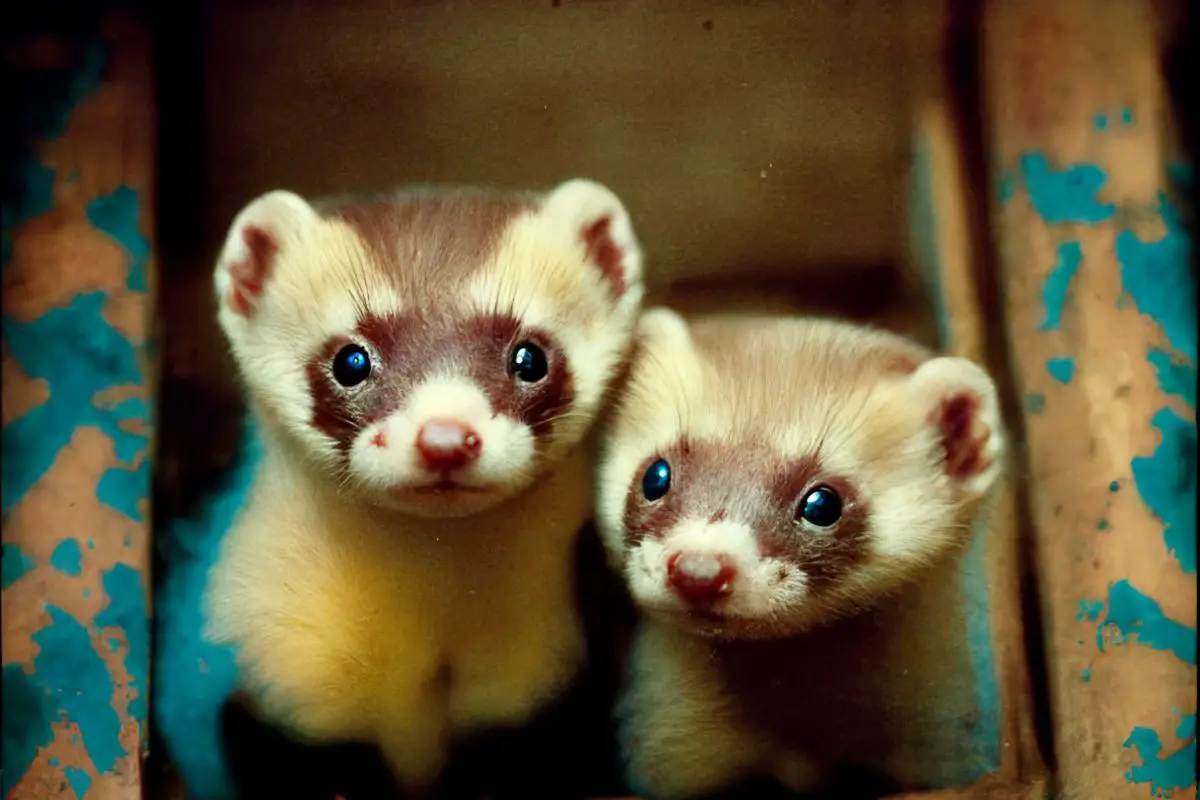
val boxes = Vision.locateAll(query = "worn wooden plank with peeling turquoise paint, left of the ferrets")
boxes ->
[2,14,155,800]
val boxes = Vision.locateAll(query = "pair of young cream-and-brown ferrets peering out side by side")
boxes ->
[209,180,1002,798]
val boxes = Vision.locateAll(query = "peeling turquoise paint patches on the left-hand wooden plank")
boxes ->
[0,41,150,796]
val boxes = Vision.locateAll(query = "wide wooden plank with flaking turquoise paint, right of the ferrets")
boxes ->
[984,0,1196,800]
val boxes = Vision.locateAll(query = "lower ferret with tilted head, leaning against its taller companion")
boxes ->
[596,308,1004,800]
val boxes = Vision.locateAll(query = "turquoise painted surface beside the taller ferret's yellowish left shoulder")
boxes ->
[154,426,262,800]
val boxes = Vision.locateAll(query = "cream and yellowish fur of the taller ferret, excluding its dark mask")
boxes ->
[208,181,643,789]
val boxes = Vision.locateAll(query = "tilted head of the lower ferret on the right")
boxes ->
[596,309,1003,638]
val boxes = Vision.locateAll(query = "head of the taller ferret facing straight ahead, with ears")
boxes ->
[215,180,642,516]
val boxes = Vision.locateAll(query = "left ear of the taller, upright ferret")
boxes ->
[214,190,319,319]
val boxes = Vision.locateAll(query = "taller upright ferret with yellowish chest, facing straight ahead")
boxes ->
[206,179,643,796]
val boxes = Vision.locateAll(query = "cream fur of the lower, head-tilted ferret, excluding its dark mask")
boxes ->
[596,309,1004,800]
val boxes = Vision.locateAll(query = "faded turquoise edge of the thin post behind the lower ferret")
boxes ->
[908,137,1010,787]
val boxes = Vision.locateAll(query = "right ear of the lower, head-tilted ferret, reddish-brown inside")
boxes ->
[911,356,1004,497]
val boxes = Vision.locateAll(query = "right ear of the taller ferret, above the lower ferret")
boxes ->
[542,179,642,299]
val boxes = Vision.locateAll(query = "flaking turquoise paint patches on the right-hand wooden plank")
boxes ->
[1019,134,1196,796]
